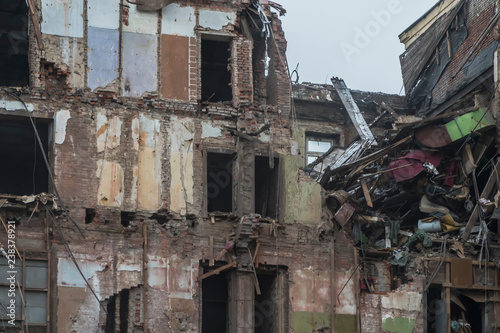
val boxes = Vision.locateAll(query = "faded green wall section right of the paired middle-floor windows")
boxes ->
[283,155,322,224]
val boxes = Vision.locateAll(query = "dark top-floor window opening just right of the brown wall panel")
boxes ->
[201,38,233,103]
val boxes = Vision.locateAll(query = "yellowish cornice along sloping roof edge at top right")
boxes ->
[398,0,461,49]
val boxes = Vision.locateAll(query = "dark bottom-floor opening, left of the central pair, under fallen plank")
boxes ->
[201,273,228,333]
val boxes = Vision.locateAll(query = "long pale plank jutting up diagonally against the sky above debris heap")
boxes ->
[332,77,377,144]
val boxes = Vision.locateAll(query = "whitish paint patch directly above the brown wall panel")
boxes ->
[161,3,196,37]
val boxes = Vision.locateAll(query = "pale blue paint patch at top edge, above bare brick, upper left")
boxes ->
[41,0,83,38]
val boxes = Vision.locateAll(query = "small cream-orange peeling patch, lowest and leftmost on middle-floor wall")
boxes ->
[97,160,124,207]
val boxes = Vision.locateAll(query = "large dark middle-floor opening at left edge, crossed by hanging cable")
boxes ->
[0,116,49,195]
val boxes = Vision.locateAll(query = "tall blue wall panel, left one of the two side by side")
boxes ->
[88,27,119,90]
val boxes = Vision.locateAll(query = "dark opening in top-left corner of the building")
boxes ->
[0,0,29,87]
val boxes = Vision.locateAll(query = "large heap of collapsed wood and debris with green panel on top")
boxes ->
[306,77,500,256]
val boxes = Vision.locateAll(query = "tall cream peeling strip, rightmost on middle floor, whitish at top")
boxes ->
[170,117,194,215]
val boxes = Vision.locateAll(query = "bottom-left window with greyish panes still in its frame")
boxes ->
[0,257,48,326]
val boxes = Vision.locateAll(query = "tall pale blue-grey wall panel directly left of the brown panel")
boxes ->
[122,32,158,97]
